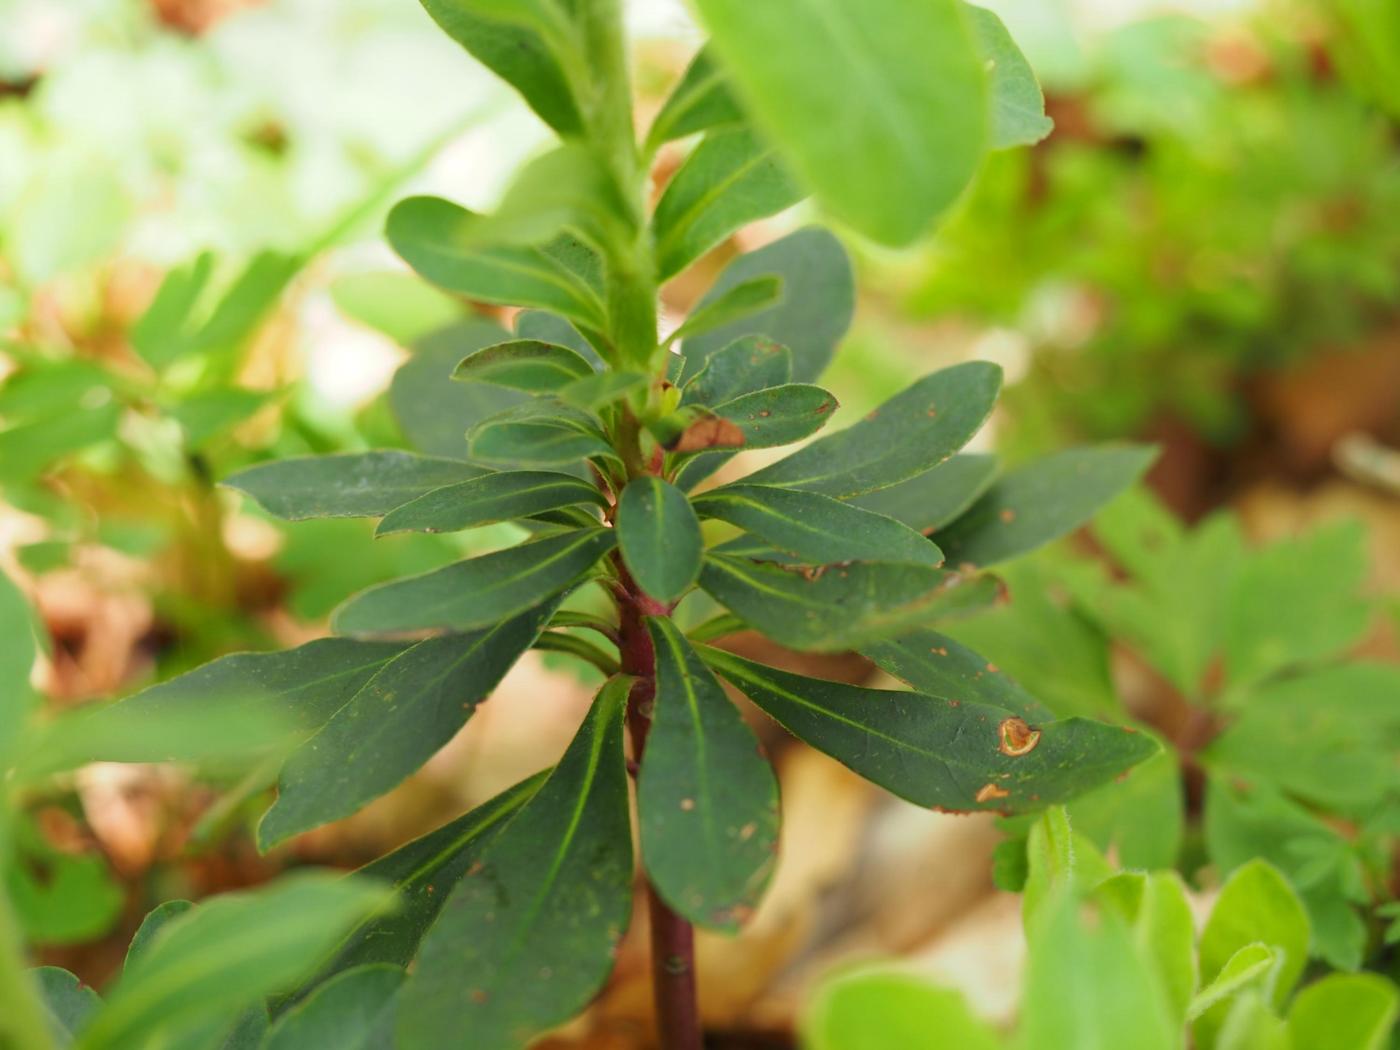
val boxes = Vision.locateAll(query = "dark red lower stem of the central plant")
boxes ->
[619,576,703,1050]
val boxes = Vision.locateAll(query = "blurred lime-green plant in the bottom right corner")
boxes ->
[804,809,1400,1050]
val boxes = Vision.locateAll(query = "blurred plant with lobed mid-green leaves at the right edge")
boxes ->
[949,491,1400,967]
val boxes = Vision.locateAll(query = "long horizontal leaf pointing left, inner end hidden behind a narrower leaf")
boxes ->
[223,449,484,521]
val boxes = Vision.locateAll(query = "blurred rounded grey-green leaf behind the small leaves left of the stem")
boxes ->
[389,319,528,459]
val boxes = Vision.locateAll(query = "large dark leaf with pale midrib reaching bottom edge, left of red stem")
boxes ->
[398,678,633,1050]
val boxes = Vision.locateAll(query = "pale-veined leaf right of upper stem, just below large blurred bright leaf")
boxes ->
[651,127,804,280]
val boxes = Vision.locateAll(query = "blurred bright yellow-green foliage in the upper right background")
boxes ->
[904,0,1400,452]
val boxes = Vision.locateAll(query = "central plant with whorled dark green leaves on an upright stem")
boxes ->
[0,0,1155,1050]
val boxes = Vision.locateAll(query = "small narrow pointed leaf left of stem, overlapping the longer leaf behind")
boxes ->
[375,470,605,536]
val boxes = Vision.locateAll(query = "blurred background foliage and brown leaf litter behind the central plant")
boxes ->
[0,0,1400,1046]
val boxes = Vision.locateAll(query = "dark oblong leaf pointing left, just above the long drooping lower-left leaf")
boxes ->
[330,528,616,634]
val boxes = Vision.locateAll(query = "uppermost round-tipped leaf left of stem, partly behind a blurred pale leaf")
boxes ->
[385,197,603,328]
